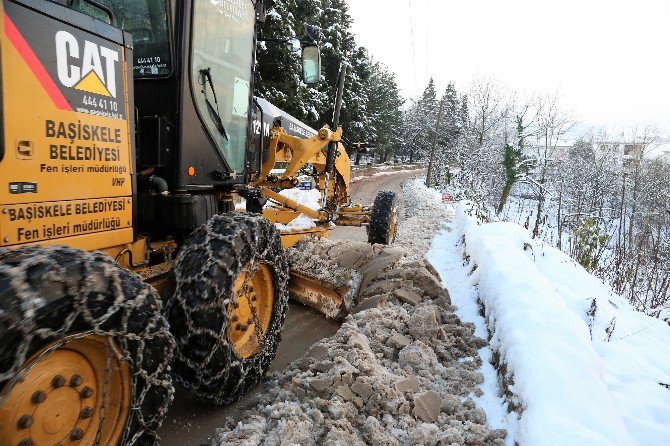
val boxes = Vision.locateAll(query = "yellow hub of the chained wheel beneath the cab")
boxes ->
[228,264,274,359]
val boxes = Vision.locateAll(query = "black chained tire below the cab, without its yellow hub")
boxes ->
[167,213,288,405]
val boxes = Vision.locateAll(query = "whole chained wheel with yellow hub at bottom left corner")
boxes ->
[0,247,174,446]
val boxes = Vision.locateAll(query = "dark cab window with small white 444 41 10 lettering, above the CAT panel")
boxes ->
[70,0,171,77]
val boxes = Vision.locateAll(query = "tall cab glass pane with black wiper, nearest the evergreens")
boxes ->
[191,0,255,173]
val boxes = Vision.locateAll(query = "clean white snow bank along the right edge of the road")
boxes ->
[456,204,670,445]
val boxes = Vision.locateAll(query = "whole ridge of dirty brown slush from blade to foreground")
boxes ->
[212,182,505,446]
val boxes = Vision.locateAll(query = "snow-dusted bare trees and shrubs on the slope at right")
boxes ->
[403,79,670,320]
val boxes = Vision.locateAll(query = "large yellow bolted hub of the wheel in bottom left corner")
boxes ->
[0,336,130,446]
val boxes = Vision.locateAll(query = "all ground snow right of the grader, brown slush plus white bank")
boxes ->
[224,180,670,446]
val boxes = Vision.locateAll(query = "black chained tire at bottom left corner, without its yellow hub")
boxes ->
[0,246,174,446]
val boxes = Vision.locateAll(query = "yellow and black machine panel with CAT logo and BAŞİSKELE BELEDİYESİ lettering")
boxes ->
[0,0,133,249]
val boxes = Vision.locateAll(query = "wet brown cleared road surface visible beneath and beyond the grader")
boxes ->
[158,170,425,446]
